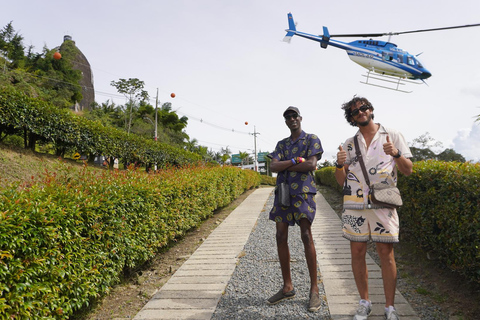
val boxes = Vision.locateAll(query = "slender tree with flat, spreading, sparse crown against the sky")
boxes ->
[110,78,148,133]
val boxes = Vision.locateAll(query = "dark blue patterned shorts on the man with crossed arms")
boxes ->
[270,193,317,226]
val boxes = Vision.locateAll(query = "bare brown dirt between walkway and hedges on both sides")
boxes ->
[75,187,480,320]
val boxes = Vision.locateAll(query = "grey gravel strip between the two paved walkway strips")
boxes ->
[212,195,330,320]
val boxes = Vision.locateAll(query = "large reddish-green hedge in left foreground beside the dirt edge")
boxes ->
[0,164,260,319]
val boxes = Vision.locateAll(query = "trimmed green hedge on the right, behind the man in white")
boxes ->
[315,161,480,283]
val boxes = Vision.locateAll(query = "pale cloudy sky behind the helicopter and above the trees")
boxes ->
[0,0,480,161]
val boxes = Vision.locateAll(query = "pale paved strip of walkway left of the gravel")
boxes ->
[134,188,273,320]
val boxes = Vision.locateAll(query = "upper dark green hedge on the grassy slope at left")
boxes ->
[0,87,201,168]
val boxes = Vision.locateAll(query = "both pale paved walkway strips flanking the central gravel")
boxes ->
[134,188,419,320]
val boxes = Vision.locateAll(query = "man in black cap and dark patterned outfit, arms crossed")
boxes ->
[267,107,323,311]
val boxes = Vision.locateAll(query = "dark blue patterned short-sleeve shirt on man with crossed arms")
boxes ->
[267,131,323,195]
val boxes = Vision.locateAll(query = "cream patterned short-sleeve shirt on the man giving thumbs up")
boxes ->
[343,125,412,209]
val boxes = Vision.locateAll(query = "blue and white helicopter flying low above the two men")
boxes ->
[283,12,480,93]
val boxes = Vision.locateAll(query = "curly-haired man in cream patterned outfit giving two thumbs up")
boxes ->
[335,97,413,320]
